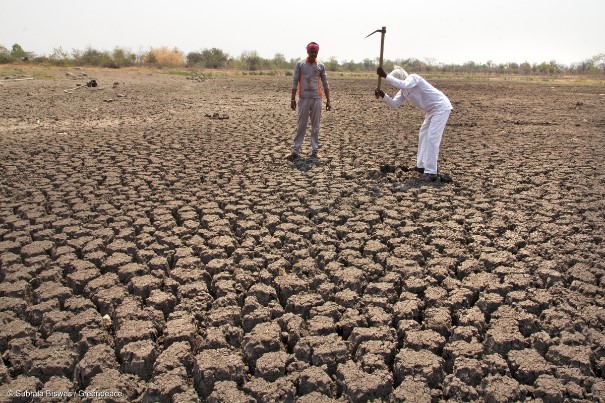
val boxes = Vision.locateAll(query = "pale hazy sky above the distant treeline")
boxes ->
[0,0,605,65]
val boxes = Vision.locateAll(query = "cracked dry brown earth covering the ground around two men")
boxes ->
[0,70,605,402]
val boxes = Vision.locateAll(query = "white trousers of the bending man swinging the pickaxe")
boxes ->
[416,110,451,174]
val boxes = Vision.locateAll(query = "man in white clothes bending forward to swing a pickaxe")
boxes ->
[374,66,452,182]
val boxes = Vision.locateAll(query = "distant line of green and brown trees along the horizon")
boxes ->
[0,44,605,75]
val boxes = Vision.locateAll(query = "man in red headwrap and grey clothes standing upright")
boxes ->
[286,42,332,161]
